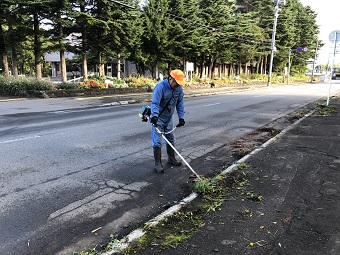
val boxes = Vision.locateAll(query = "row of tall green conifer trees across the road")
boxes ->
[0,0,323,81]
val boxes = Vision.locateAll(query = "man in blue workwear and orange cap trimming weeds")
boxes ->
[150,69,185,173]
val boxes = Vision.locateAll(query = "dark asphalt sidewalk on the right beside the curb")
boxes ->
[115,96,340,255]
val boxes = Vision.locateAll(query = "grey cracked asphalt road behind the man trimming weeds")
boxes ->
[0,84,340,255]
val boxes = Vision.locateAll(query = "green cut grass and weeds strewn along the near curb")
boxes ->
[122,166,249,255]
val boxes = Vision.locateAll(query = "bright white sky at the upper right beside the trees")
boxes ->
[298,0,340,64]
